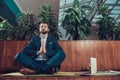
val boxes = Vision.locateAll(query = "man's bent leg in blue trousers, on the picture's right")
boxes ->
[42,50,66,71]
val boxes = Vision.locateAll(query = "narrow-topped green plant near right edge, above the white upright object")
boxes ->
[96,5,117,40]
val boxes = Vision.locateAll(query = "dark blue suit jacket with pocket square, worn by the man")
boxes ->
[22,35,63,58]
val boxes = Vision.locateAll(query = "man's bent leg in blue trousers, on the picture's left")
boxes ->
[15,53,42,73]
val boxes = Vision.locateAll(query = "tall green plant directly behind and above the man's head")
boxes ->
[38,4,62,39]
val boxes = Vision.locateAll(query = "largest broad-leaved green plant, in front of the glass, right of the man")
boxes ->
[62,0,91,40]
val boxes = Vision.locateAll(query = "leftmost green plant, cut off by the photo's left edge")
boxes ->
[0,20,13,40]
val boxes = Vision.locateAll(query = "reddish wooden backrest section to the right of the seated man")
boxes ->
[59,40,120,71]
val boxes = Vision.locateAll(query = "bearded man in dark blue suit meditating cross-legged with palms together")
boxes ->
[15,23,66,74]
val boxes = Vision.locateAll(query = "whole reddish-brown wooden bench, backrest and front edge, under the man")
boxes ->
[0,40,120,80]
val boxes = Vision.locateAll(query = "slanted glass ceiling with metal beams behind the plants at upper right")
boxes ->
[59,0,120,26]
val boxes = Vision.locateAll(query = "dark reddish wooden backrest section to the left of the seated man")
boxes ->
[0,41,26,72]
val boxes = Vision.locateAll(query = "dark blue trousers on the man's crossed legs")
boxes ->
[15,51,66,72]
